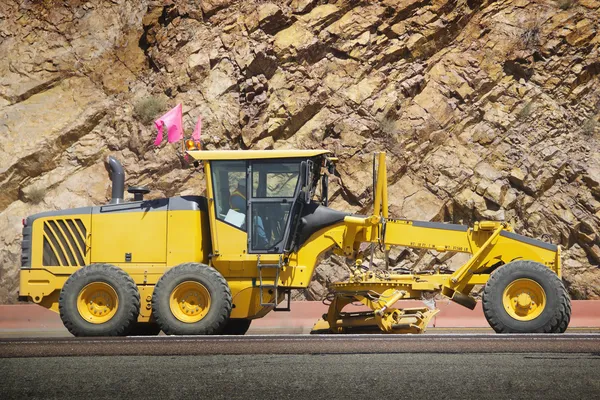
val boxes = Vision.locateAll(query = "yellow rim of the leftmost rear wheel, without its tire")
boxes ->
[77,282,119,324]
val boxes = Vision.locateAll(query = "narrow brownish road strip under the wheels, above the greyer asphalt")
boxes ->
[0,333,600,358]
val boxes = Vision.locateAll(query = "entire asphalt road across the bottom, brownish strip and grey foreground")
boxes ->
[0,334,600,399]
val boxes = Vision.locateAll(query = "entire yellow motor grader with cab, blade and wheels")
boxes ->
[20,150,571,336]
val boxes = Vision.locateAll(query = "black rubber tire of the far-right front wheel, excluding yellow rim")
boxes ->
[483,260,571,333]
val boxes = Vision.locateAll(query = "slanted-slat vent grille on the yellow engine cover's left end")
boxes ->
[42,218,87,267]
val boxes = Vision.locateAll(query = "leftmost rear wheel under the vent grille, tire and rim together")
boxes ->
[58,264,140,336]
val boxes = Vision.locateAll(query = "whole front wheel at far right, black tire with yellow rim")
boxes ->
[483,260,571,333]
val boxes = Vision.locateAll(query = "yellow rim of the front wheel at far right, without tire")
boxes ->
[502,278,546,321]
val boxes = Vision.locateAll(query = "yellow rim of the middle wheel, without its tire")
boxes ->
[169,281,210,324]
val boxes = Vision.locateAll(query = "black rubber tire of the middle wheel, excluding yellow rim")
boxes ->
[152,263,231,335]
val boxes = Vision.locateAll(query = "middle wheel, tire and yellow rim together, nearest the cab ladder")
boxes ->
[152,263,231,335]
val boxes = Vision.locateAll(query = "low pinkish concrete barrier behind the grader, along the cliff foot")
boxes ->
[0,300,600,334]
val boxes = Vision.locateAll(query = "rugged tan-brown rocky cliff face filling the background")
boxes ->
[0,0,600,301]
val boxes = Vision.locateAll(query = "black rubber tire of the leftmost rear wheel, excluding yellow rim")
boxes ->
[58,264,140,336]
